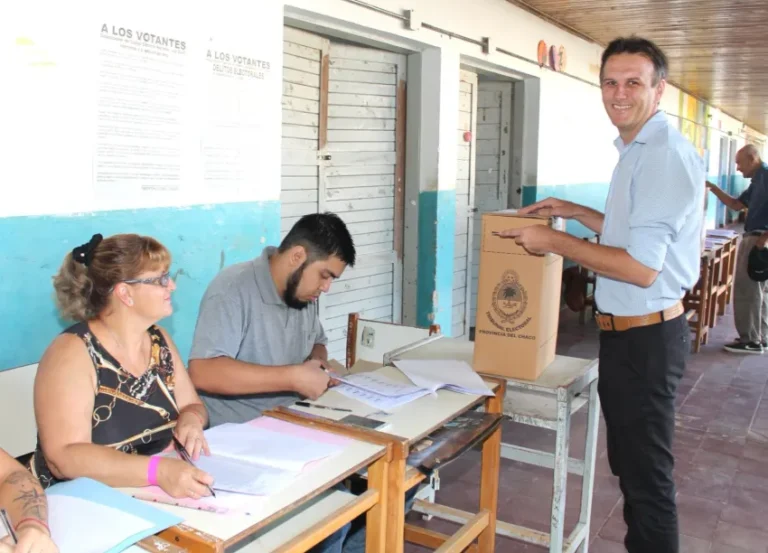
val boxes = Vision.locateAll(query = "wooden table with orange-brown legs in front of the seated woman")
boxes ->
[121,414,395,553]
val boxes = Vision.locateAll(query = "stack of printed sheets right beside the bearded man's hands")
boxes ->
[333,373,430,411]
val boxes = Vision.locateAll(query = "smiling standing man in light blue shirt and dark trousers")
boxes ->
[502,37,705,553]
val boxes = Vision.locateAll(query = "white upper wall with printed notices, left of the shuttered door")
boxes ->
[0,0,283,217]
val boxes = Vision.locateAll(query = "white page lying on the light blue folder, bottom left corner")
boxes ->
[0,495,152,553]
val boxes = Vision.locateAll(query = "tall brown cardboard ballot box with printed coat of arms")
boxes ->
[473,210,563,380]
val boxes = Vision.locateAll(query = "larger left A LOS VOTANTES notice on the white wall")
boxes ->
[94,21,190,197]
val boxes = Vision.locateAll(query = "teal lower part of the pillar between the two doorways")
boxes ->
[416,190,456,334]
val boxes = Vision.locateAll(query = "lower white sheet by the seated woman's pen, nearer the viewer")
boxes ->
[195,455,299,495]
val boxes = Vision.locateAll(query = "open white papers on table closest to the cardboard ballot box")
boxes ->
[394,359,493,396]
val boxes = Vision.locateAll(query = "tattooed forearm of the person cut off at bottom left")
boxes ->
[0,449,59,553]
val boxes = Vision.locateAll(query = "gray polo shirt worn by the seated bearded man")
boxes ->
[189,246,328,426]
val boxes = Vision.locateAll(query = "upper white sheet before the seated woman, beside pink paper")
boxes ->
[205,423,342,472]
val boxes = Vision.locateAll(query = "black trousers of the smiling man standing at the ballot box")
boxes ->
[598,316,690,553]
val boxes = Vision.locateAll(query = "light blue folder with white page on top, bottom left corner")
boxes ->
[0,478,182,553]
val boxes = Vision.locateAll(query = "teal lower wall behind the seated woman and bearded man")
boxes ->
[0,201,280,370]
